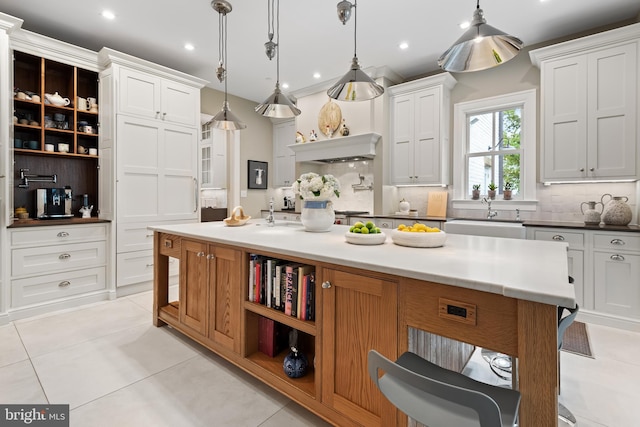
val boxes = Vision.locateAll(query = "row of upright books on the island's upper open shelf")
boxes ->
[247,254,315,321]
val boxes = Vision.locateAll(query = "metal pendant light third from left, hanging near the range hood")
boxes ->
[327,0,384,101]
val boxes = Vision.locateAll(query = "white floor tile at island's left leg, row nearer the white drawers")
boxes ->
[16,298,151,357]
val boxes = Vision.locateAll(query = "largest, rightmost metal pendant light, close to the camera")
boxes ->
[438,0,523,73]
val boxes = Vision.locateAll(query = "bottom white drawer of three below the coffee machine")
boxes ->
[11,267,106,308]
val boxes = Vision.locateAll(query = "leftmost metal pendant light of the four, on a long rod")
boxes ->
[209,0,247,130]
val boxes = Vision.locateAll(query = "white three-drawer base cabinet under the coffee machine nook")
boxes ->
[9,223,109,310]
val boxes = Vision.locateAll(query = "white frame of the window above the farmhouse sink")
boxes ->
[452,89,538,210]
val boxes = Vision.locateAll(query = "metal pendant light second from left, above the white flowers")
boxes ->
[255,0,301,118]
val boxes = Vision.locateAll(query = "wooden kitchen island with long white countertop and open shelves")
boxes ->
[151,220,575,427]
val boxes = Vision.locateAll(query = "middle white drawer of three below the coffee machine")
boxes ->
[11,242,106,277]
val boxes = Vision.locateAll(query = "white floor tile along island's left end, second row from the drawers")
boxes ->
[32,324,197,408]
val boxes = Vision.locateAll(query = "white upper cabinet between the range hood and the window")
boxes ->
[389,73,456,185]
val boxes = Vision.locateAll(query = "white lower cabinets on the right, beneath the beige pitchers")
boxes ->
[527,227,640,328]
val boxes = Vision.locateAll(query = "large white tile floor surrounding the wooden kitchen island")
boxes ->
[0,292,640,427]
